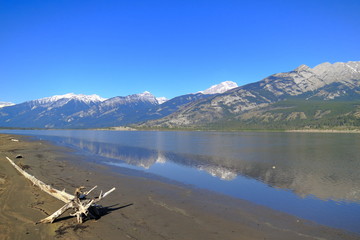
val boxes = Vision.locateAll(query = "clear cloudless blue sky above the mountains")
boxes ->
[0,0,360,103]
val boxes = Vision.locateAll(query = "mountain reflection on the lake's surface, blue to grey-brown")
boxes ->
[59,137,360,202]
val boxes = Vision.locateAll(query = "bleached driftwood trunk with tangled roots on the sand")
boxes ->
[6,157,115,223]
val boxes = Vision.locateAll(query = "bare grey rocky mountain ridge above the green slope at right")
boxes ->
[142,62,360,128]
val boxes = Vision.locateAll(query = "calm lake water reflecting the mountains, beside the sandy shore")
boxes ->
[0,130,360,233]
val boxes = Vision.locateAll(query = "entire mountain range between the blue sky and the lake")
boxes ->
[0,62,360,130]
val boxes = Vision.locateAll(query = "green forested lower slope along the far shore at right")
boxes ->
[131,98,360,131]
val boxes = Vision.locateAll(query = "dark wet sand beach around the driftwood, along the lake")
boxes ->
[0,135,360,240]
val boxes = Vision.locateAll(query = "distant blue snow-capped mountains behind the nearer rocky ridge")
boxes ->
[0,81,237,128]
